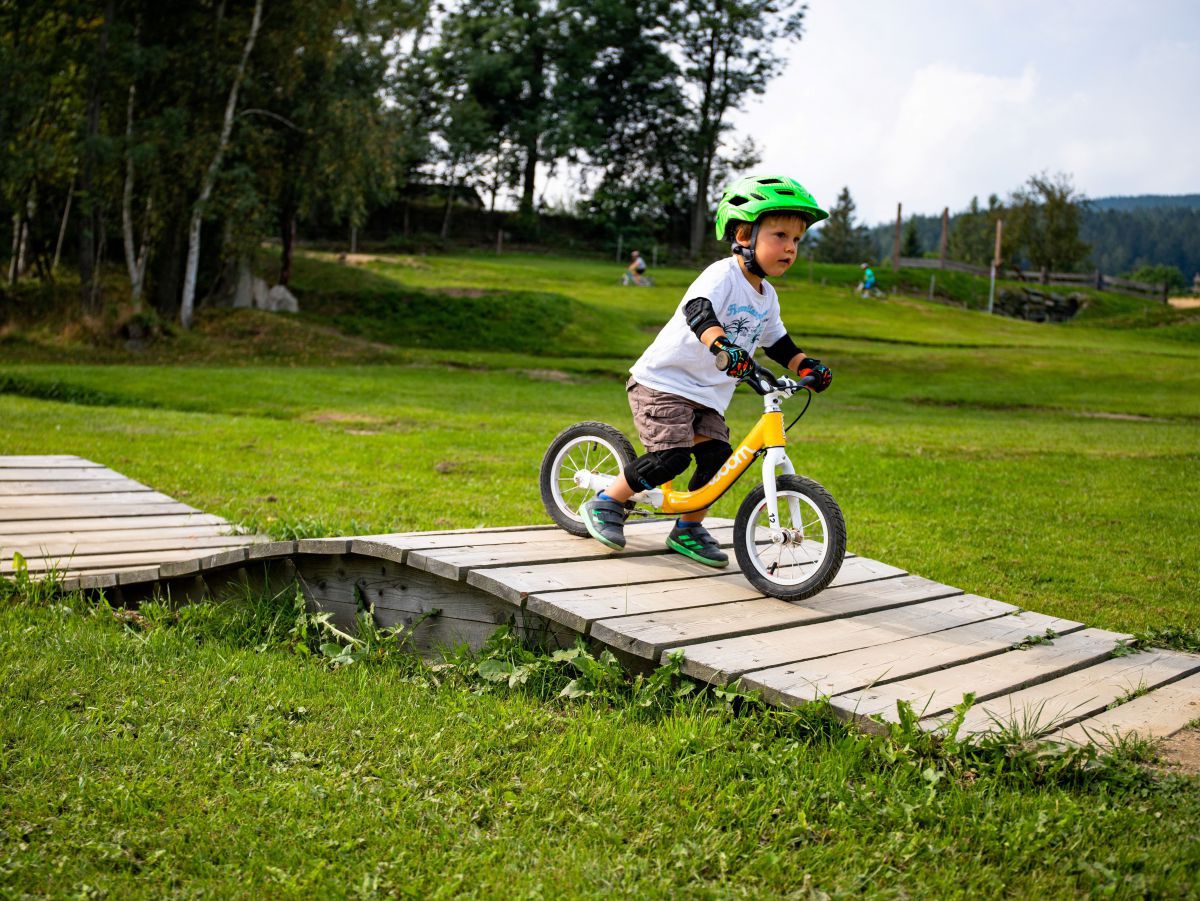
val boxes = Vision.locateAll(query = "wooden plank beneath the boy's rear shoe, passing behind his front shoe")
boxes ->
[407,521,733,582]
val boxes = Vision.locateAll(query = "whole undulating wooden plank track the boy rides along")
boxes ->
[0,457,1200,743]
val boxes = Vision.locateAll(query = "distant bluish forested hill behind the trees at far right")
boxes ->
[870,194,1200,282]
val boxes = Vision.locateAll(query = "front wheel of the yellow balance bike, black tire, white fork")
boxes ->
[733,475,846,601]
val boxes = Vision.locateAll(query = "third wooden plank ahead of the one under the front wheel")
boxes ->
[742,612,1099,707]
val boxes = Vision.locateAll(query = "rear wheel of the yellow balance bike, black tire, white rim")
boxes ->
[538,422,637,537]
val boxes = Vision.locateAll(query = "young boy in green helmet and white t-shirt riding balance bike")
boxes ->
[580,175,833,566]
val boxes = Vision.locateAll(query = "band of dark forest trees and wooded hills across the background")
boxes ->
[0,0,1200,326]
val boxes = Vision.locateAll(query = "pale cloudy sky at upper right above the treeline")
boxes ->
[736,0,1200,223]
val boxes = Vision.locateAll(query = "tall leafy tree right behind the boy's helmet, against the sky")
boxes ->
[672,0,806,257]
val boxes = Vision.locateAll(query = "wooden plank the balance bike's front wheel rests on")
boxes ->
[526,557,916,633]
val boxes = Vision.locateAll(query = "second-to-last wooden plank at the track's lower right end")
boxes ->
[936,650,1200,735]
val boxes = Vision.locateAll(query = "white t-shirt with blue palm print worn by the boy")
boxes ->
[630,257,786,414]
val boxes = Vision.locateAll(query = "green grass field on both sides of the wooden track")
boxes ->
[0,254,1200,896]
